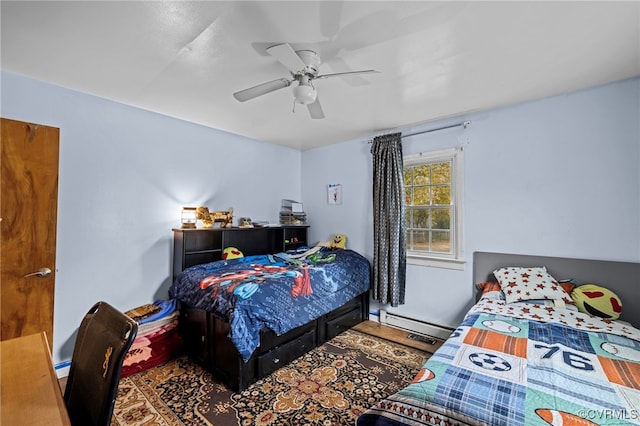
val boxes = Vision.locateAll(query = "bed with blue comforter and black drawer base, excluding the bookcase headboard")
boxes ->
[169,247,371,391]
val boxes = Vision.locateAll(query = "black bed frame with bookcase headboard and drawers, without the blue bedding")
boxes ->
[173,226,369,392]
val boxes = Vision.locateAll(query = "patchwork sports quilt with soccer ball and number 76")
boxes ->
[357,298,640,426]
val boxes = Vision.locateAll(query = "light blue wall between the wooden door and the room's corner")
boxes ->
[0,72,301,363]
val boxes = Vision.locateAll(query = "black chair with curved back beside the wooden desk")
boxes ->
[64,302,138,426]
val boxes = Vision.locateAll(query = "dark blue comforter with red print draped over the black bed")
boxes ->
[169,250,370,362]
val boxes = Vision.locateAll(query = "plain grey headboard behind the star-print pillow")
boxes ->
[473,252,640,328]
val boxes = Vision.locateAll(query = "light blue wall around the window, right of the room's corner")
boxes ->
[302,79,640,327]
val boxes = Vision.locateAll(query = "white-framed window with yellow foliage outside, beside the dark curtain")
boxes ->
[404,149,462,269]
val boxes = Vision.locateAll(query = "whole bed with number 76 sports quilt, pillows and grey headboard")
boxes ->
[357,253,640,426]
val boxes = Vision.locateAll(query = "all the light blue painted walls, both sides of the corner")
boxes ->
[0,72,640,362]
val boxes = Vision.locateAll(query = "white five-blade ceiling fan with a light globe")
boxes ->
[233,43,379,118]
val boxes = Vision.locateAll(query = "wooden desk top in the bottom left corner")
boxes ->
[0,332,71,425]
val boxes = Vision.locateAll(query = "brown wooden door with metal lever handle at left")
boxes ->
[0,118,60,347]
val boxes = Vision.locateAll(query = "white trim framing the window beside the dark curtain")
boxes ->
[403,147,465,270]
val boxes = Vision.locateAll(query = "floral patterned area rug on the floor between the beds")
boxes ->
[111,330,430,426]
